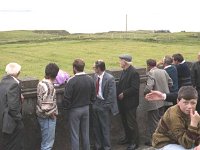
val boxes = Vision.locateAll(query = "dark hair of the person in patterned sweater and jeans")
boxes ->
[45,63,59,79]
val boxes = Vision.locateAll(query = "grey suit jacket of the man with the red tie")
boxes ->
[94,72,119,115]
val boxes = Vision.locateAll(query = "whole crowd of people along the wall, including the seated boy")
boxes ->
[0,51,200,150]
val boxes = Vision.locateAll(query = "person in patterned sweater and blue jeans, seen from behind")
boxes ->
[36,63,59,150]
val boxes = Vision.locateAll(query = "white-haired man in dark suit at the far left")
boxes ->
[0,63,24,150]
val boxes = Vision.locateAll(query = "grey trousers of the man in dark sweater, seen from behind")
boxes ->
[69,106,90,150]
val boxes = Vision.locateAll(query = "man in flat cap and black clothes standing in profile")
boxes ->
[117,54,140,150]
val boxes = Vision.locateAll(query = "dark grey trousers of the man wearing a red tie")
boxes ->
[93,105,111,150]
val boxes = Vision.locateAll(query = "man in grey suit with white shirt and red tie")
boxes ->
[93,60,118,150]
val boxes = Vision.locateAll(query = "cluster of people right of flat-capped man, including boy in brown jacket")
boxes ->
[144,53,200,150]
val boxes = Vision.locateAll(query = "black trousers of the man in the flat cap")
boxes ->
[120,108,139,145]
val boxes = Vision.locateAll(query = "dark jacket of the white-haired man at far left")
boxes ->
[0,75,22,133]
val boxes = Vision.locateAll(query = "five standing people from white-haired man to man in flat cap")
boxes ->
[0,54,140,150]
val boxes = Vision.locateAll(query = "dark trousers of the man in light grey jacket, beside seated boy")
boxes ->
[147,107,165,143]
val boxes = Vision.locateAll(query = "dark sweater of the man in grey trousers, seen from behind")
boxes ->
[63,73,96,109]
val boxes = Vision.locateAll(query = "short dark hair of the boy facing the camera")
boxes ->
[178,86,198,100]
